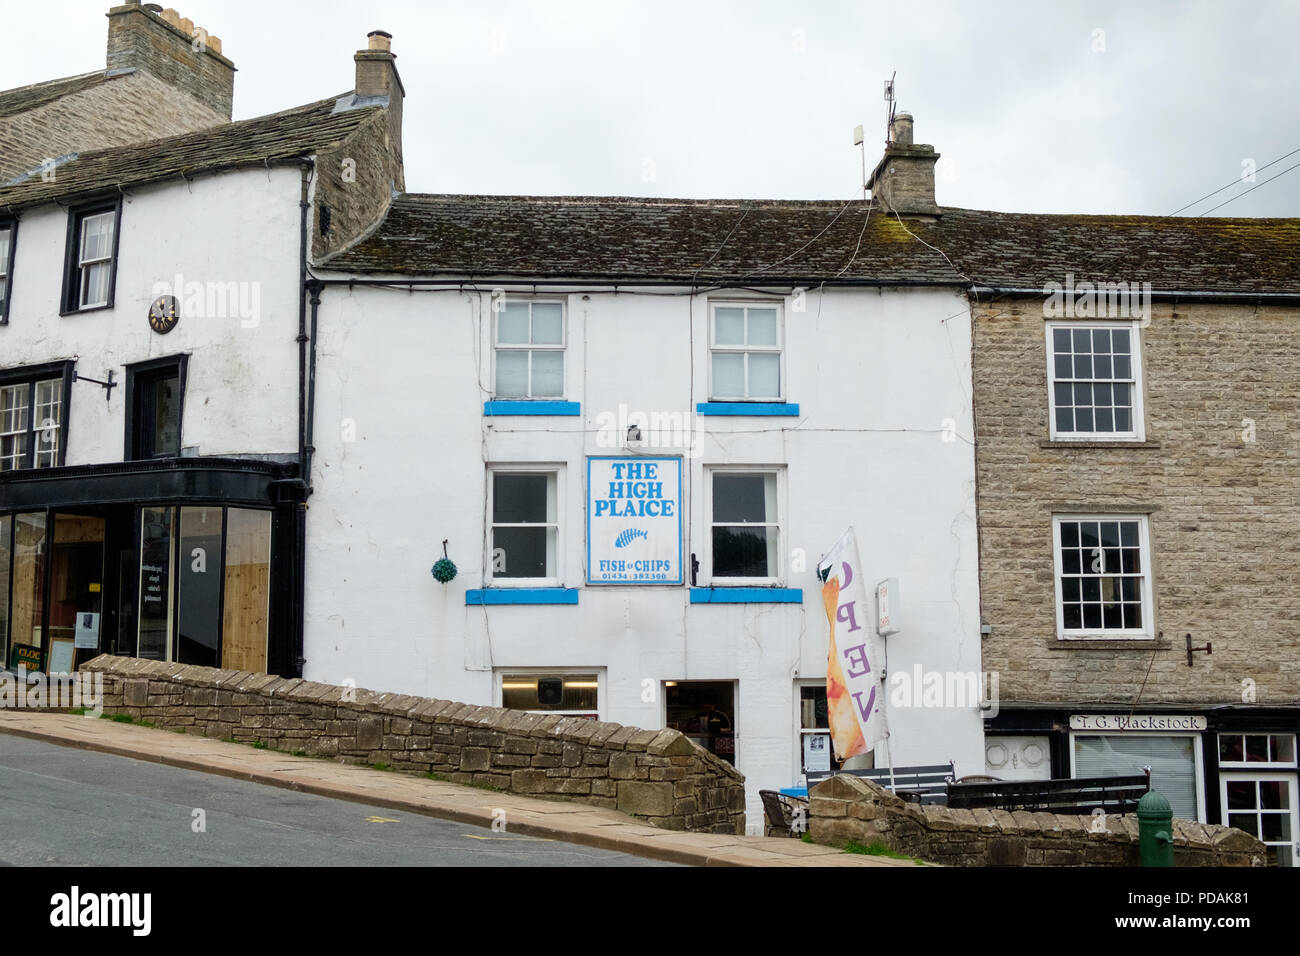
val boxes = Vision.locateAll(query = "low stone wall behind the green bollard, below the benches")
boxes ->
[809,775,1270,866]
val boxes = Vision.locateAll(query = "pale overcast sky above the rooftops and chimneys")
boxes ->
[10,0,1300,216]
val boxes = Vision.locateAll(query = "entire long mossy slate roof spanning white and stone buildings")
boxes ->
[322,194,1300,294]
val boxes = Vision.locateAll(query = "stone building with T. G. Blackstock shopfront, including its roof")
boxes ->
[918,209,1300,864]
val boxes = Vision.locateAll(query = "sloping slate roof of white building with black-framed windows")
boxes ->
[0,94,381,208]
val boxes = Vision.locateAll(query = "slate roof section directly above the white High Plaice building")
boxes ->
[326,194,963,285]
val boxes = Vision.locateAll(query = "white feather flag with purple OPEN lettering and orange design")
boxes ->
[818,528,887,760]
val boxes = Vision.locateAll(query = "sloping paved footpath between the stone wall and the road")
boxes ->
[0,710,914,866]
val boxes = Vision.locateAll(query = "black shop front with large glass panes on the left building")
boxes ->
[0,458,302,676]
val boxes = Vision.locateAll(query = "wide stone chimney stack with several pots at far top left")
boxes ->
[107,0,235,120]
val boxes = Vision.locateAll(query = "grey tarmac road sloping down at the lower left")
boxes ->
[0,734,671,866]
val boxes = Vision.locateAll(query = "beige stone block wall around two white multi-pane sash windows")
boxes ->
[974,303,1300,706]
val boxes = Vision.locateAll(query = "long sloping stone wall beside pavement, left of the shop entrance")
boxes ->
[82,654,745,834]
